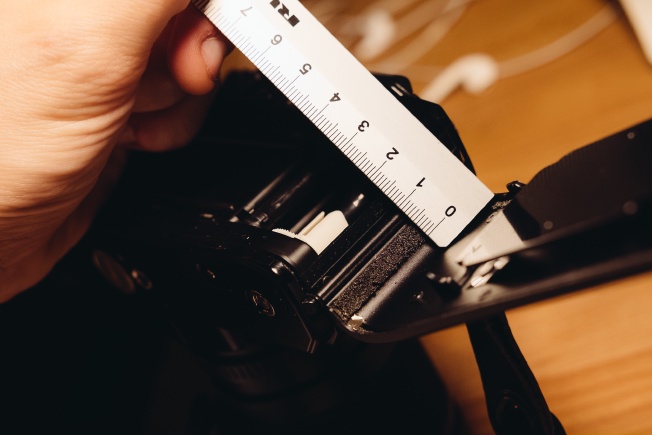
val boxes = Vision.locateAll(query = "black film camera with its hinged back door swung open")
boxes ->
[90,73,652,352]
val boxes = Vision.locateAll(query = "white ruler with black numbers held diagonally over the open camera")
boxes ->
[192,0,493,247]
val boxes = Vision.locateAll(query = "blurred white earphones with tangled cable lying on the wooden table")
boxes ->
[308,0,618,102]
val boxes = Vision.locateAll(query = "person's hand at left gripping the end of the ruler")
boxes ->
[0,0,228,302]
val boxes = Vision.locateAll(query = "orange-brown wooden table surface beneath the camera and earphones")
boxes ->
[227,0,652,435]
